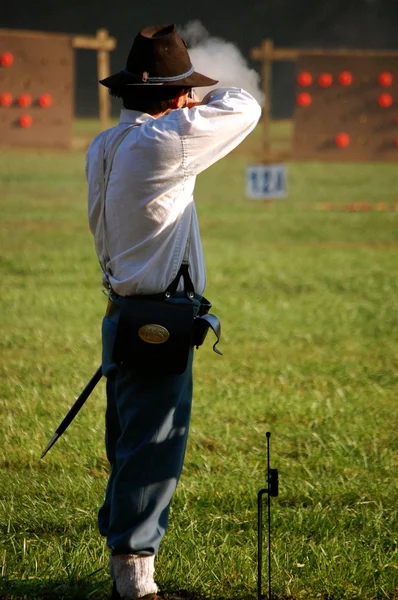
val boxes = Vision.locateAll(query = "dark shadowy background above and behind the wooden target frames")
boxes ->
[0,0,398,118]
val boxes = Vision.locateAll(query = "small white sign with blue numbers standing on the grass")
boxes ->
[246,164,287,200]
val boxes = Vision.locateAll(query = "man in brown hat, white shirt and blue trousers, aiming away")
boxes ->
[87,25,261,600]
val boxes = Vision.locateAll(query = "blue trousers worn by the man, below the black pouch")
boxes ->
[98,292,199,556]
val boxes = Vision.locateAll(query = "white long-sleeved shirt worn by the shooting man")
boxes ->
[86,88,261,296]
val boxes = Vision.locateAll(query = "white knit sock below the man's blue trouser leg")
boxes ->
[110,554,158,599]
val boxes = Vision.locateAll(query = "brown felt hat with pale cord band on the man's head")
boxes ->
[100,25,218,88]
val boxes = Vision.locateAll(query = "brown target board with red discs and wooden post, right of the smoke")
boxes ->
[251,40,398,162]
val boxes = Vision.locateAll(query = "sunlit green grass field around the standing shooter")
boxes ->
[0,127,398,600]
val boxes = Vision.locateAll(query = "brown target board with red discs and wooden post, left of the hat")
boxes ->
[0,29,116,148]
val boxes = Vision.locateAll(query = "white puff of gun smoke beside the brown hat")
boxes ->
[179,20,264,106]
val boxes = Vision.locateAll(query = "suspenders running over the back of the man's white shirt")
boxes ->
[95,125,195,300]
